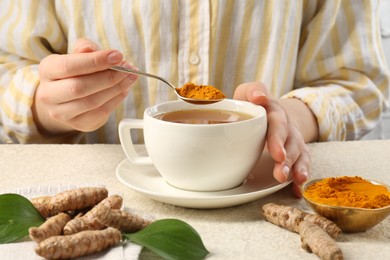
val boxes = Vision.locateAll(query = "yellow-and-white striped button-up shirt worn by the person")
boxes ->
[0,0,389,143]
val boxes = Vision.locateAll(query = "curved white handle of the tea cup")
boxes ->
[118,118,152,165]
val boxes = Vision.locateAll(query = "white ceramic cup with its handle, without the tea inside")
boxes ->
[119,99,267,191]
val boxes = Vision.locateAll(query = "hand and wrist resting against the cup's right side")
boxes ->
[233,82,318,197]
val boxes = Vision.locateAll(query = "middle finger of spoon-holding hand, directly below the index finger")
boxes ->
[47,64,137,103]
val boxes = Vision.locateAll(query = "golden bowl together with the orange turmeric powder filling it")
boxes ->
[301,176,390,232]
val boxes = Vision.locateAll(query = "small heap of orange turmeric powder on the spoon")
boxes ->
[176,82,225,100]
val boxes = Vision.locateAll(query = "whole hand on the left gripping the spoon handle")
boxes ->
[32,39,137,135]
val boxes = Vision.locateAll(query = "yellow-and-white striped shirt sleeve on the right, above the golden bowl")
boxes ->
[283,0,389,141]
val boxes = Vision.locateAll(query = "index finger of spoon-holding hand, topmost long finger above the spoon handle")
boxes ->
[39,50,123,80]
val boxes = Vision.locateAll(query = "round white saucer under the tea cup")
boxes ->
[116,152,290,209]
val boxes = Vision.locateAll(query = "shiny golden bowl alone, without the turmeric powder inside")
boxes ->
[301,179,390,233]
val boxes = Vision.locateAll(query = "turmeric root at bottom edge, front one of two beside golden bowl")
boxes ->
[298,220,343,260]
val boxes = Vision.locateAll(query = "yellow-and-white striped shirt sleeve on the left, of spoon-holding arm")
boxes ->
[0,0,80,143]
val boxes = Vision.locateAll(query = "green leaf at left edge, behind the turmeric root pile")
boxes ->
[0,193,45,244]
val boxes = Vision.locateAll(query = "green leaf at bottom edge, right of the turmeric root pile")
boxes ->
[123,219,209,260]
